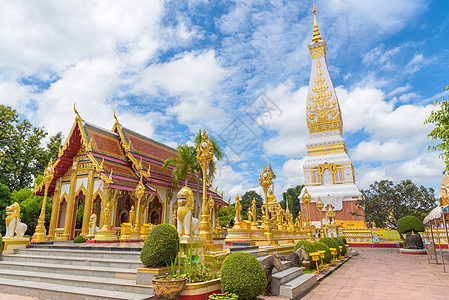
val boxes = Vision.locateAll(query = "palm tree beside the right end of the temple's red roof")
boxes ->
[162,144,197,189]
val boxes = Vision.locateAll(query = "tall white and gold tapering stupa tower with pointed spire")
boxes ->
[300,7,364,226]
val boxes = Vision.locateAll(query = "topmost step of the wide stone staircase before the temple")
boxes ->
[16,248,140,261]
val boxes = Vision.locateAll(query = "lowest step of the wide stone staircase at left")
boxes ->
[0,279,157,300]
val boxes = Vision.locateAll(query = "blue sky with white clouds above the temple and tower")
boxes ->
[0,0,449,202]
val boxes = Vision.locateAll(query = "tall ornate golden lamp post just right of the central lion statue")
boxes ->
[196,130,214,243]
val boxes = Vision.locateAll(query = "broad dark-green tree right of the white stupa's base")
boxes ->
[357,179,436,229]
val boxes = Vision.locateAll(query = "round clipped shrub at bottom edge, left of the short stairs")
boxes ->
[221,252,267,300]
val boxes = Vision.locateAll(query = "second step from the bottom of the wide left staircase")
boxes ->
[0,269,153,295]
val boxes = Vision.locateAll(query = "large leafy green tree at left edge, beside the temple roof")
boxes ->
[0,105,62,191]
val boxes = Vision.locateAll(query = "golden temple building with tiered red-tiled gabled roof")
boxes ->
[35,110,229,240]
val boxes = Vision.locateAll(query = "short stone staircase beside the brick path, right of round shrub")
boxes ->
[257,256,317,299]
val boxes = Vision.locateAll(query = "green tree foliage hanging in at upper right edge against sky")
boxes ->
[424,85,449,174]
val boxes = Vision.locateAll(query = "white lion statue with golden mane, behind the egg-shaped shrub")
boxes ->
[176,186,200,237]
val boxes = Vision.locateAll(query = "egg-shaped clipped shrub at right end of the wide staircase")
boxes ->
[140,224,179,268]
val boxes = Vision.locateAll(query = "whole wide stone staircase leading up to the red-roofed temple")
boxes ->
[0,247,156,300]
